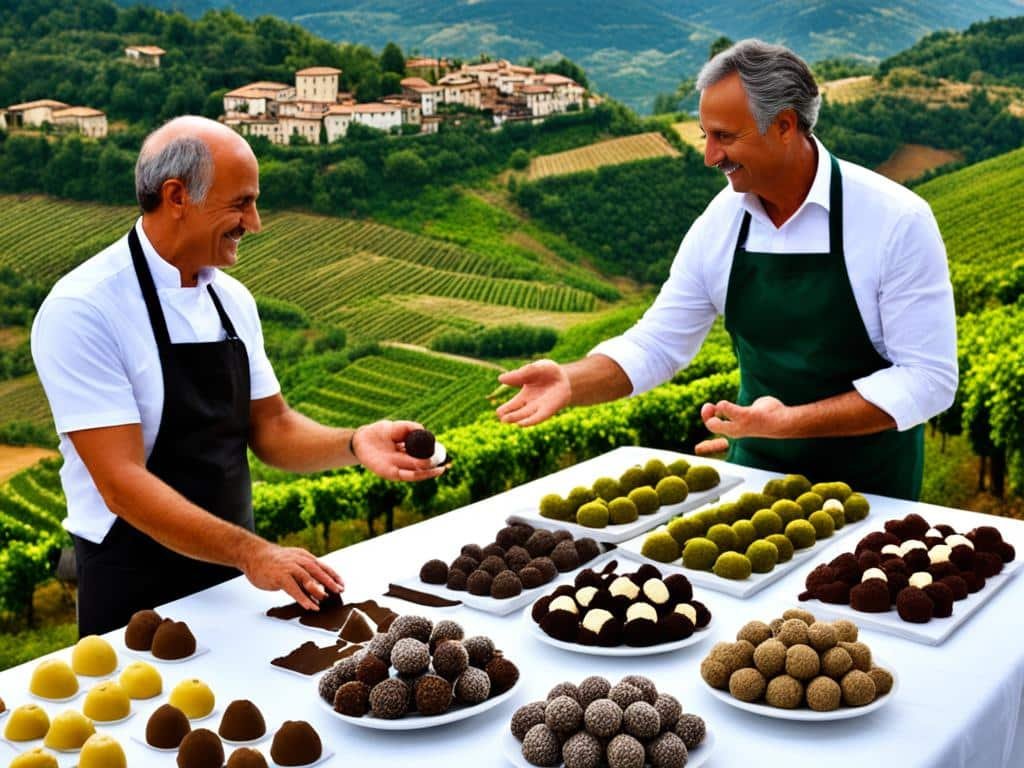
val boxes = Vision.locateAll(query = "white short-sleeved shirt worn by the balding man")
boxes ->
[32,219,281,543]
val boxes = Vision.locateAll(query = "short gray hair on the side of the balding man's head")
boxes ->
[135,134,213,213]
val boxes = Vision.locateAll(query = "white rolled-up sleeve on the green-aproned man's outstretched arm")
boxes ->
[590,216,718,394]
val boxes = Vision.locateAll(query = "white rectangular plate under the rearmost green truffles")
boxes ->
[509,466,743,544]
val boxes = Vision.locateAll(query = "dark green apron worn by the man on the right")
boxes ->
[725,158,925,500]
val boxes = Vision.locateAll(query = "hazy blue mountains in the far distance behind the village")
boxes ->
[119,0,1024,113]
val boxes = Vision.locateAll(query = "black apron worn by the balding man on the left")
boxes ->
[74,228,253,637]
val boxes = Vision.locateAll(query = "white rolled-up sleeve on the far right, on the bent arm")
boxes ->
[853,207,958,430]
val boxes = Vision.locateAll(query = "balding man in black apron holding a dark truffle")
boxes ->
[32,117,441,636]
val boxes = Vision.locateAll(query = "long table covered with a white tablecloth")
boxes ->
[0,449,1024,768]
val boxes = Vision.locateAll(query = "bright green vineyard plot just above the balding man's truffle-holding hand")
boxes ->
[291,346,499,431]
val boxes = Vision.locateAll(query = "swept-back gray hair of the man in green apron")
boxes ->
[696,38,821,134]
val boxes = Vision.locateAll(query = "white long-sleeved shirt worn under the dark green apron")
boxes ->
[591,138,957,430]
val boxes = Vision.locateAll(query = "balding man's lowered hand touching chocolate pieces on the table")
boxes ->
[240,540,345,610]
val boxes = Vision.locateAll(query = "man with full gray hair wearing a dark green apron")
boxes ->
[498,40,957,499]
